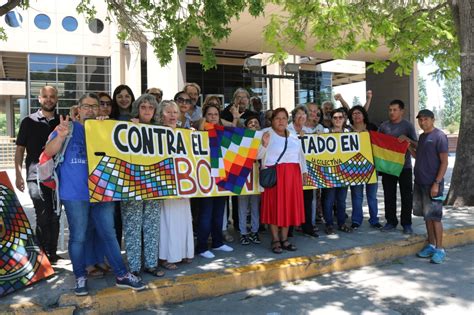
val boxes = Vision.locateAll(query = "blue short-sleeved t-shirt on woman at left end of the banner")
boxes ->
[50,122,89,200]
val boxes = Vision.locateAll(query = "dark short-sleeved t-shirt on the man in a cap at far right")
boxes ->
[414,128,448,185]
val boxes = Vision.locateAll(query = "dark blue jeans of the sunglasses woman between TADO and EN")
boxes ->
[323,187,347,226]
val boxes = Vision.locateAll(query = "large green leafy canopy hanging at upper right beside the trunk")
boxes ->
[265,0,459,77]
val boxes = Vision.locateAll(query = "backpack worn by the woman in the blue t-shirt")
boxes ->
[36,121,74,212]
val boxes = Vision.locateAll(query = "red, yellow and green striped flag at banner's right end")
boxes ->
[369,131,410,177]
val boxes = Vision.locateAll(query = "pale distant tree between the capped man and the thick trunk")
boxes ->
[443,77,461,127]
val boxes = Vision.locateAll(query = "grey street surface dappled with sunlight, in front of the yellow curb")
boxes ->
[131,245,474,315]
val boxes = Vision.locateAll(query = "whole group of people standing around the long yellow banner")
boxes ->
[15,83,447,295]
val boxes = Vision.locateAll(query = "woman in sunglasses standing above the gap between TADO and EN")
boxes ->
[323,108,352,235]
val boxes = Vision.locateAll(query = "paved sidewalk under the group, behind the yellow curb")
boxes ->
[0,157,474,314]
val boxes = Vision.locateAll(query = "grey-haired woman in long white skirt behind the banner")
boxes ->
[159,101,194,270]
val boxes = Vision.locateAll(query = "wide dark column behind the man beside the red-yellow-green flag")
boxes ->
[366,64,418,124]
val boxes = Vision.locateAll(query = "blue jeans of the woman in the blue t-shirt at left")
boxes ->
[62,200,127,278]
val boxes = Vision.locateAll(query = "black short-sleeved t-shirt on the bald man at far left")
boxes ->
[16,110,59,181]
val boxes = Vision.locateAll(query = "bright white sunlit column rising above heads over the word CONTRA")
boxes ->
[146,45,186,99]
